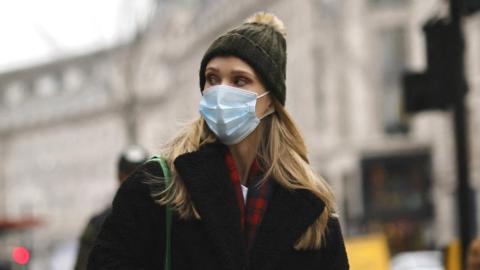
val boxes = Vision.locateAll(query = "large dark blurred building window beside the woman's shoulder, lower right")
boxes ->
[361,150,434,254]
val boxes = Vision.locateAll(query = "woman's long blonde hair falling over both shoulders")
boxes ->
[152,99,334,250]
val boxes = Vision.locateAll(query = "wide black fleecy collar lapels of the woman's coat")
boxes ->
[174,143,324,270]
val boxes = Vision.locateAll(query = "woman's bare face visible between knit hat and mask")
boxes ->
[204,56,272,117]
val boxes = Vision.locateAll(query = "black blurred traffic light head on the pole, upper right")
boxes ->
[402,19,463,113]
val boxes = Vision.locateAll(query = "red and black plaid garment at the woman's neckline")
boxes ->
[225,150,271,250]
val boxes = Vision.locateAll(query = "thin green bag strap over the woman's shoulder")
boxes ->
[151,156,172,270]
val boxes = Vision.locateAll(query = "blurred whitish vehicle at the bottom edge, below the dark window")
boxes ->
[390,251,445,270]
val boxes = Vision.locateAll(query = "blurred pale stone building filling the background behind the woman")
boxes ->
[0,0,480,269]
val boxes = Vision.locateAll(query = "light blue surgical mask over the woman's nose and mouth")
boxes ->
[199,84,273,145]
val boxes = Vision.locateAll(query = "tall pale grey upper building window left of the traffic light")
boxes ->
[372,27,406,133]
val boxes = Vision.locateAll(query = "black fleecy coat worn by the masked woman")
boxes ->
[88,143,348,270]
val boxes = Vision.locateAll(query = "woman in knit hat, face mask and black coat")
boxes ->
[89,13,348,270]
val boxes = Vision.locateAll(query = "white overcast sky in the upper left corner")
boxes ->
[0,0,152,72]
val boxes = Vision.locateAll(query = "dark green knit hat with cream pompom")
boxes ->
[200,12,287,105]
